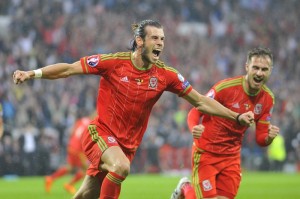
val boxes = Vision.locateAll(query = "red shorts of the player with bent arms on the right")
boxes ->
[192,145,241,198]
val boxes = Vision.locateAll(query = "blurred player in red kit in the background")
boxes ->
[45,117,91,195]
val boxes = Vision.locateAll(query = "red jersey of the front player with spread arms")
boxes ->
[81,52,192,150]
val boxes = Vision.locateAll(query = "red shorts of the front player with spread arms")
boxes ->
[82,125,135,176]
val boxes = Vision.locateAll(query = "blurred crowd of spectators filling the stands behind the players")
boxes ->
[0,0,300,175]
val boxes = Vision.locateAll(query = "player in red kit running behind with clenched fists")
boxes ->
[171,47,279,199]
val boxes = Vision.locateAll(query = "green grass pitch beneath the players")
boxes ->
[0,172,300,199]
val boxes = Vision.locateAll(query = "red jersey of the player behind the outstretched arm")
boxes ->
[188,76,275,154]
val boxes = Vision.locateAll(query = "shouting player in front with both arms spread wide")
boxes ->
[13,20,253,198]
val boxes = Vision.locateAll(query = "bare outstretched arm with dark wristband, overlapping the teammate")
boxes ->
[183,89,254,125]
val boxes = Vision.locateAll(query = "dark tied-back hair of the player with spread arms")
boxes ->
[130,19,162,51]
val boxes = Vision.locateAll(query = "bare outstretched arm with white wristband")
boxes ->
[13,61,83,84]
